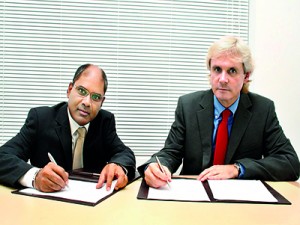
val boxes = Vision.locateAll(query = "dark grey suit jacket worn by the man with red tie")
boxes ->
[138,90,300,180]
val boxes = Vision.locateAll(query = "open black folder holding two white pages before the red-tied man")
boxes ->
[137,177,291,205]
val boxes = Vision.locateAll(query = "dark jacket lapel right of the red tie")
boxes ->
[225,94,252,164]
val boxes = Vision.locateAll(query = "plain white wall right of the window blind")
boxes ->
[249,0,300,159]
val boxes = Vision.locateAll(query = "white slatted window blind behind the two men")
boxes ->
[0,0,249,156]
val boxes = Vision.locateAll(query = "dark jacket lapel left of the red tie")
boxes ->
[197,91,214,168]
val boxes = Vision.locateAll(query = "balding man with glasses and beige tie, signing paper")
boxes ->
[0,64,135,192]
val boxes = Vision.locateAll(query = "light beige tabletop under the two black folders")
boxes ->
[0,179,300,225]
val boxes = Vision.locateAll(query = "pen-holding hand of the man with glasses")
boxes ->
[34,162,69,192]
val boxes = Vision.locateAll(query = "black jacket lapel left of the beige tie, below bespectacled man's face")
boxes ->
[55,104,72,169]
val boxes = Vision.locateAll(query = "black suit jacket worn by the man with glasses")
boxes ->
[0,102,135,186]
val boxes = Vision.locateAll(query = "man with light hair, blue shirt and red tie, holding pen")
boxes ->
[138,37,300,188]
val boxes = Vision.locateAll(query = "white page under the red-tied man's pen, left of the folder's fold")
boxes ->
[148,179,210,201]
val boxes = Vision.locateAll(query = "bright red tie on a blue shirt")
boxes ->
[214,109,231,165]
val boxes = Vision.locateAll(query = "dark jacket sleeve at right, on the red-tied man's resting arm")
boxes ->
[238,102,300,181]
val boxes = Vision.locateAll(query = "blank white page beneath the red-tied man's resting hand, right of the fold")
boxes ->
[208,180,278,202]
